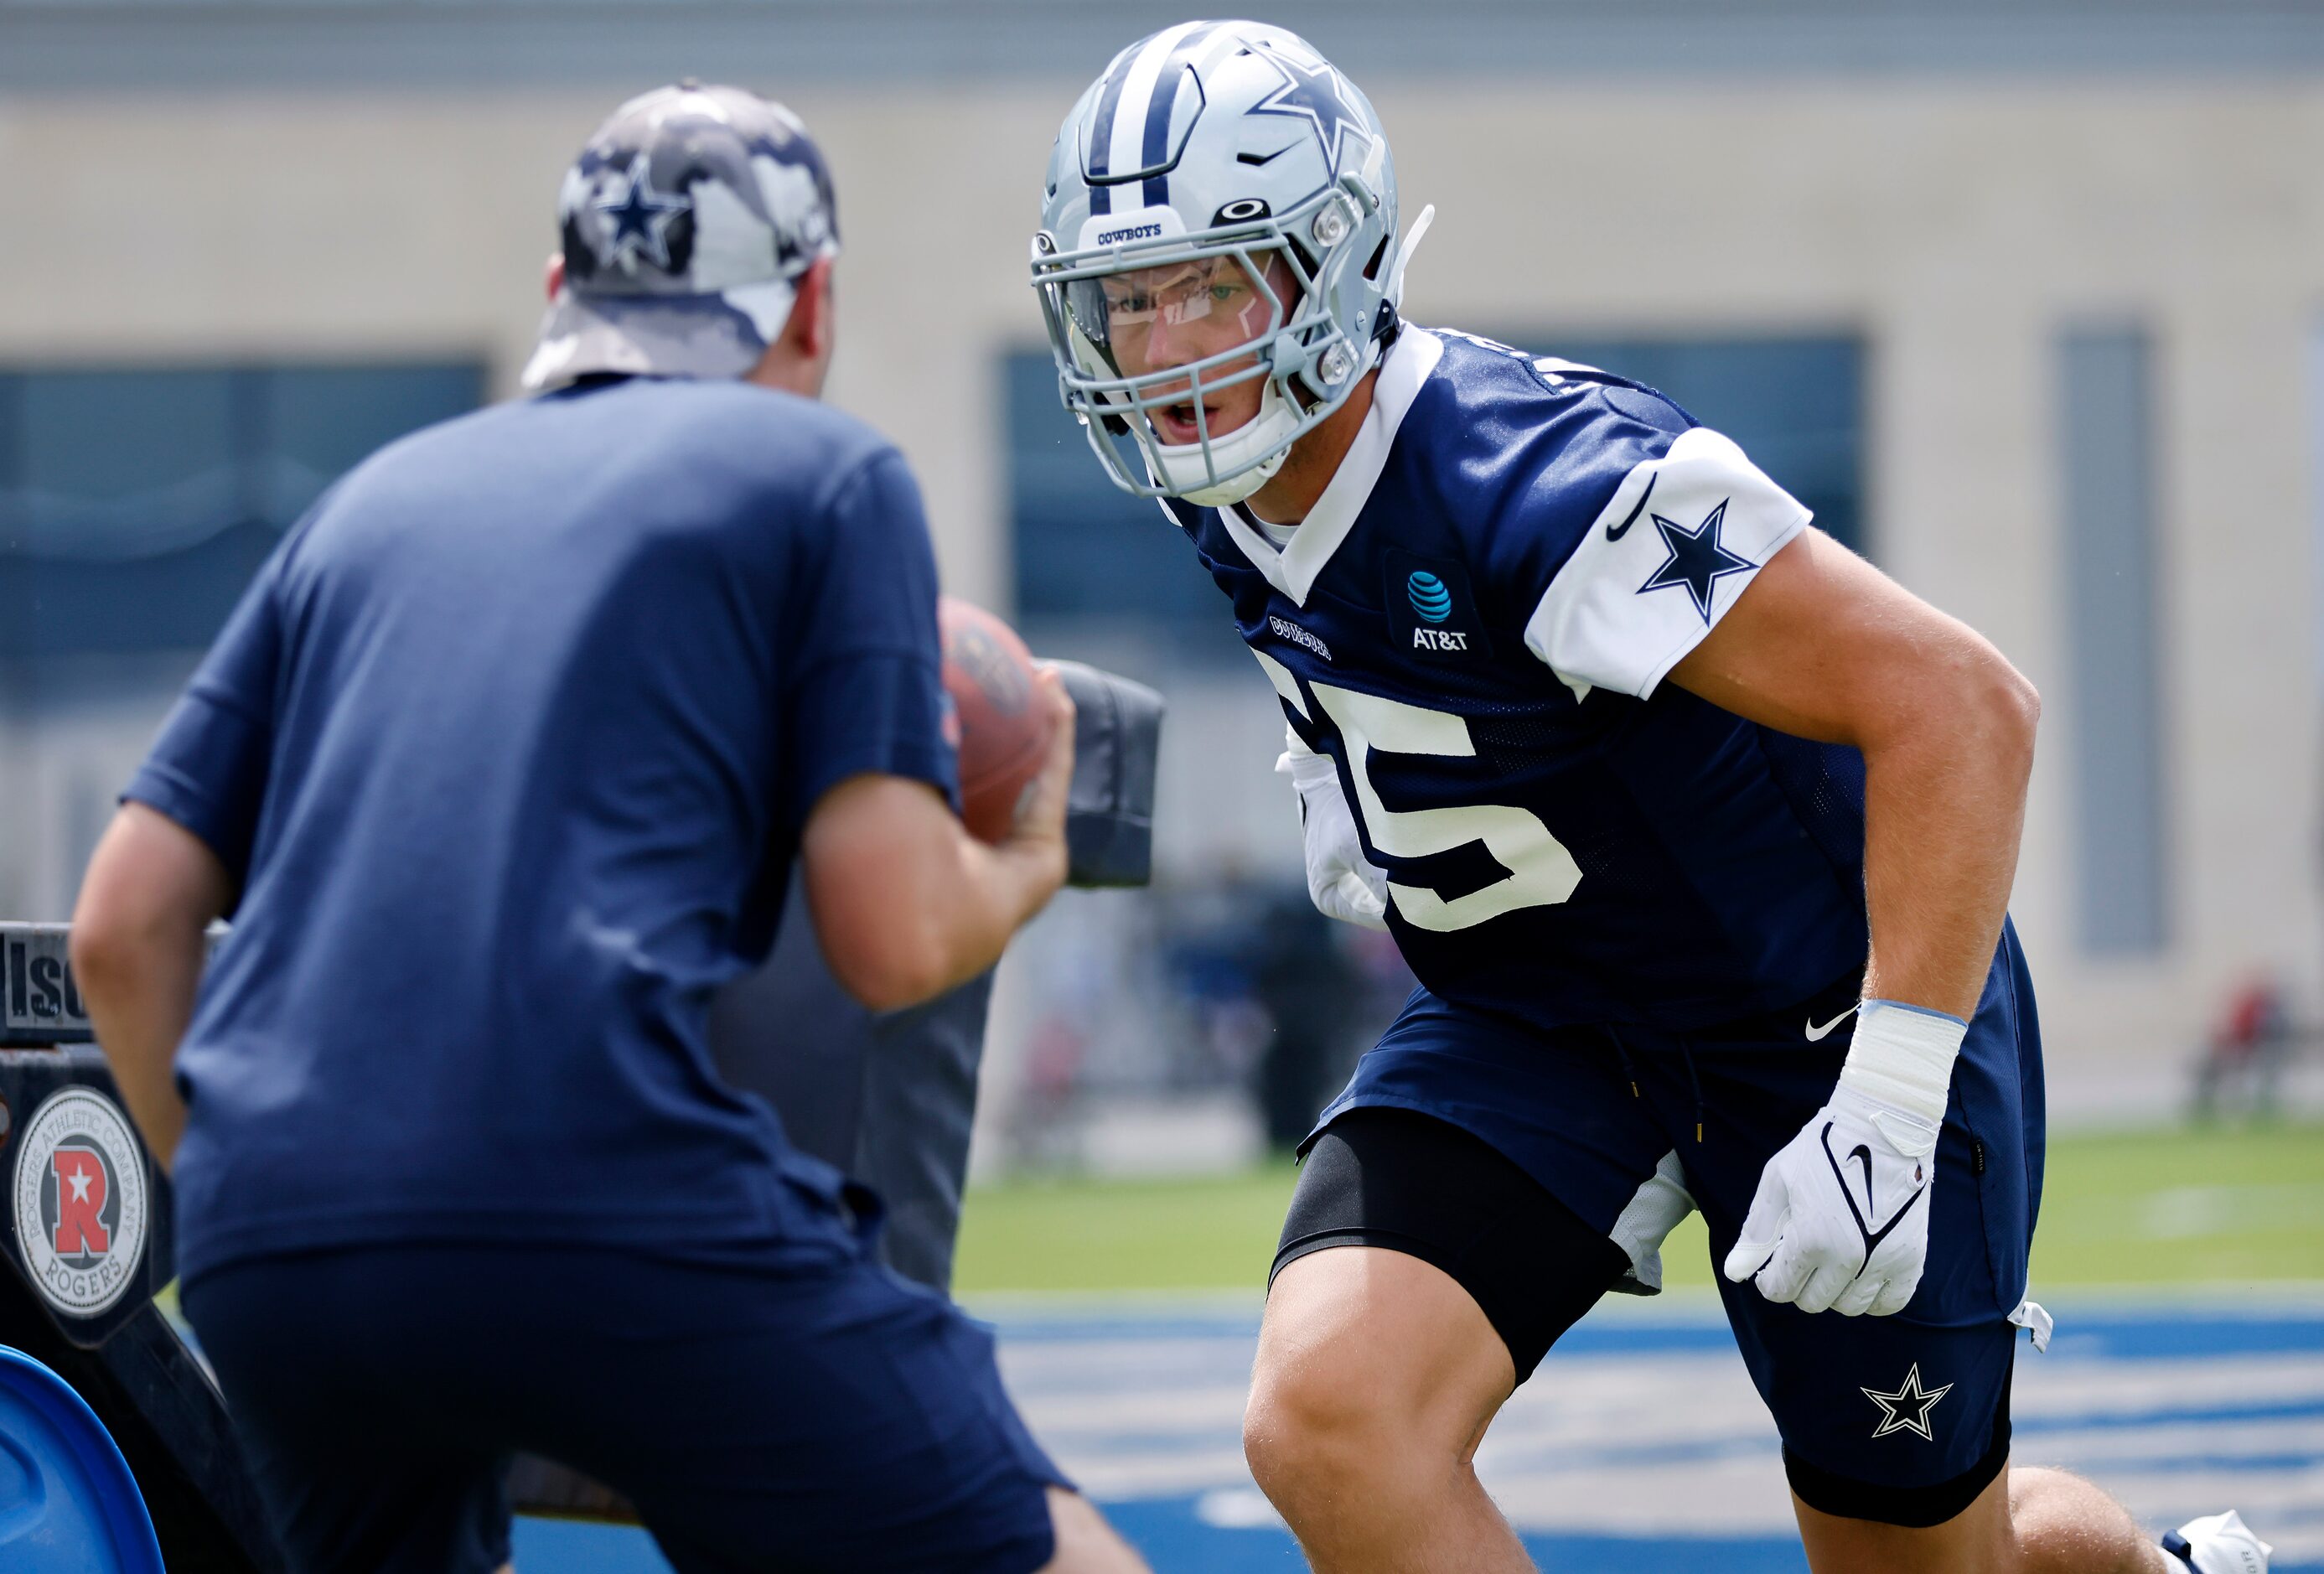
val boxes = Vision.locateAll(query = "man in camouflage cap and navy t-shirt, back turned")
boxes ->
[72,84,1139,1574]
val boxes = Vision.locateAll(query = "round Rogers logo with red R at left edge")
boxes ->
[9,1088,148,1318]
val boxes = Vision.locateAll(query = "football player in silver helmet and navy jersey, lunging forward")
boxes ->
[1032,21,2266,1574]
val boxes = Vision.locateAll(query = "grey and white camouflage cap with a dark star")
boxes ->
[525,81,839,391]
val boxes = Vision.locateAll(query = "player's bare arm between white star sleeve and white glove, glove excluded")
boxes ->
[1669,530,2041,1018]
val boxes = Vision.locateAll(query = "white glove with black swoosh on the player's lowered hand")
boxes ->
[1726,1000,1969,1316]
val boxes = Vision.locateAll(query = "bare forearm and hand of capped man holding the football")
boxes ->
[802,672,1074,1012]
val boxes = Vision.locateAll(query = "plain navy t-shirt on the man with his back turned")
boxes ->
[126,381,955,1276]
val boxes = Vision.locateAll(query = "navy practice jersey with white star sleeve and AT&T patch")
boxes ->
[1167,328,1866,1030]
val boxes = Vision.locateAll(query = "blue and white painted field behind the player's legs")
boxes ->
[516,1297,2324,1574]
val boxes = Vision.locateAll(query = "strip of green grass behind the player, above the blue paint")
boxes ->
[957,1123,2324,1295]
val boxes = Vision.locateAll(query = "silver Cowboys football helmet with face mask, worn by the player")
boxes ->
[1032,21,1429,507]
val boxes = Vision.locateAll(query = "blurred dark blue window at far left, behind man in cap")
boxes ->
[0,365,484,919]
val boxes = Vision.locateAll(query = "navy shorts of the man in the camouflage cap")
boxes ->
[184,1209,1067,1574]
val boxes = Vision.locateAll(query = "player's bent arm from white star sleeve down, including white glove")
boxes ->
[1671,530,2041,1316]
